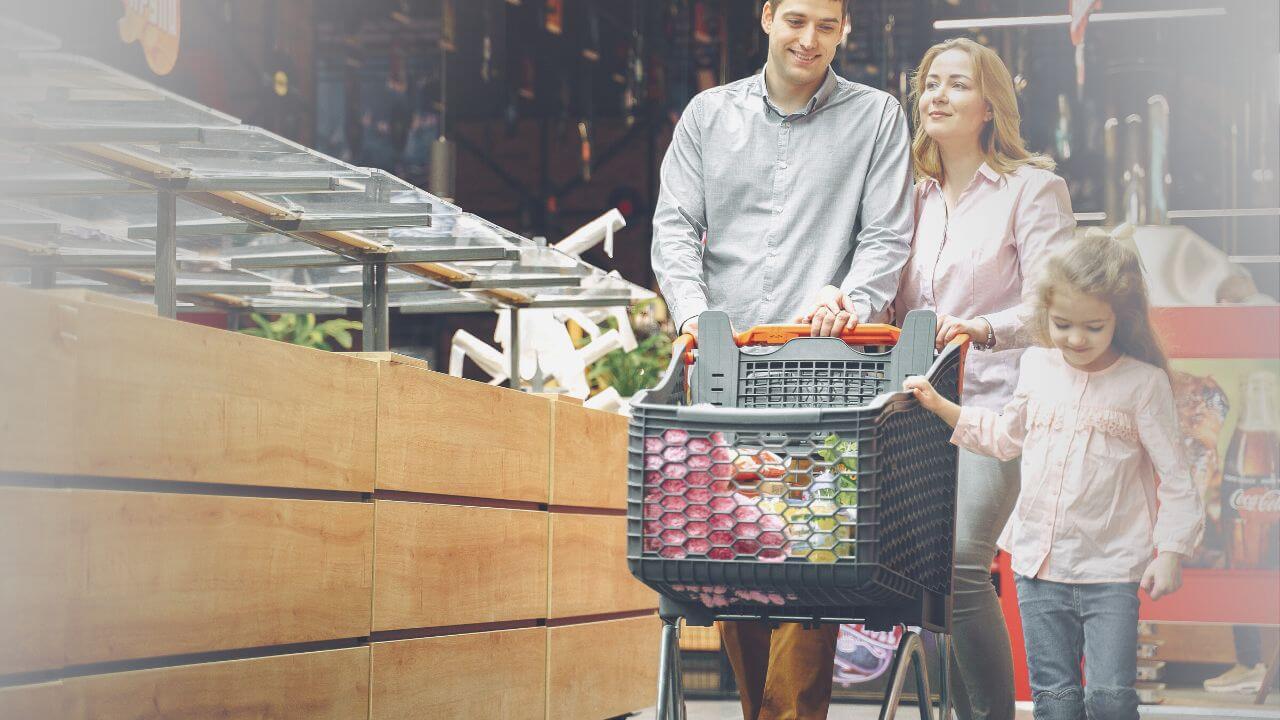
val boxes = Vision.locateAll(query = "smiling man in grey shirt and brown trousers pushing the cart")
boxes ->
[653,0,914,720]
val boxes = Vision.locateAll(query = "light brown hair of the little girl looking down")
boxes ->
[1032,234,1169,373]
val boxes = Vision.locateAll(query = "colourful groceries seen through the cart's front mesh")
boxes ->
[643,429,858,561]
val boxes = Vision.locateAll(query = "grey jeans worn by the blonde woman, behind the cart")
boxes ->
[951,450,1020,720]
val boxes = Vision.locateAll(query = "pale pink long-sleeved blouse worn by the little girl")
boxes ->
[951,347,1204,583]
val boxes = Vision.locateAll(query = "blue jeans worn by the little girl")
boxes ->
[1018,575,1138,720]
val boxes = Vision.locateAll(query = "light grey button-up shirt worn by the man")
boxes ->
[652,69,914,331]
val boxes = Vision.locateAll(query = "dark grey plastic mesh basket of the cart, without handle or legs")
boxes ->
[627,322,960,626]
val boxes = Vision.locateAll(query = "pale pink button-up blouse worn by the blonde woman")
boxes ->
[893,163,1075,410]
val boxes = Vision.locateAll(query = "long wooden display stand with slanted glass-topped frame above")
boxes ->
[0,22,658,720]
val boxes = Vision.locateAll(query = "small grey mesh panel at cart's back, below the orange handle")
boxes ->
[737,360,886,407]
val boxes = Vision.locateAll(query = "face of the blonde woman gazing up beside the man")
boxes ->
[919,49,991,145]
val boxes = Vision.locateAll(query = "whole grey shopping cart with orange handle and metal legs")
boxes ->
[627,310,968,720]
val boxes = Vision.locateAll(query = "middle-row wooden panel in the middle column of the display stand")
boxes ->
[374,500,547,630]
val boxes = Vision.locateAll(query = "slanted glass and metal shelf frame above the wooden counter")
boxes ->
[0,18,653,378]
